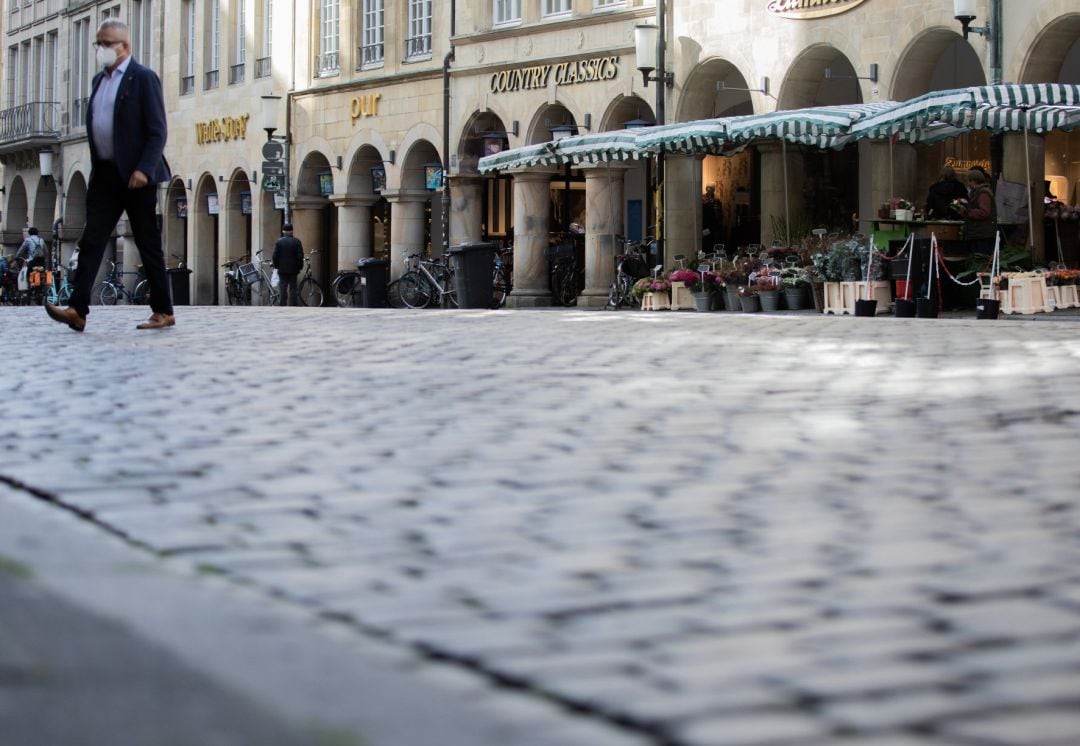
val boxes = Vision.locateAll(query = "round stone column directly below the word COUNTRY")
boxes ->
[505,168,553,308]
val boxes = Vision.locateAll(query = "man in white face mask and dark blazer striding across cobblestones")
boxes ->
[45,18,176,331]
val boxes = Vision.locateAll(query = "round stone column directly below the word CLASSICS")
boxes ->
[578,166,625,308]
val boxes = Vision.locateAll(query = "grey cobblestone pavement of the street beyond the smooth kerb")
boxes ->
[0,308,1080,746]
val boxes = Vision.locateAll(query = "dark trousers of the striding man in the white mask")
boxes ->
[70,162,173,316]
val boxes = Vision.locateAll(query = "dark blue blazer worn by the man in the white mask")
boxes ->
[86,59,171,184]
